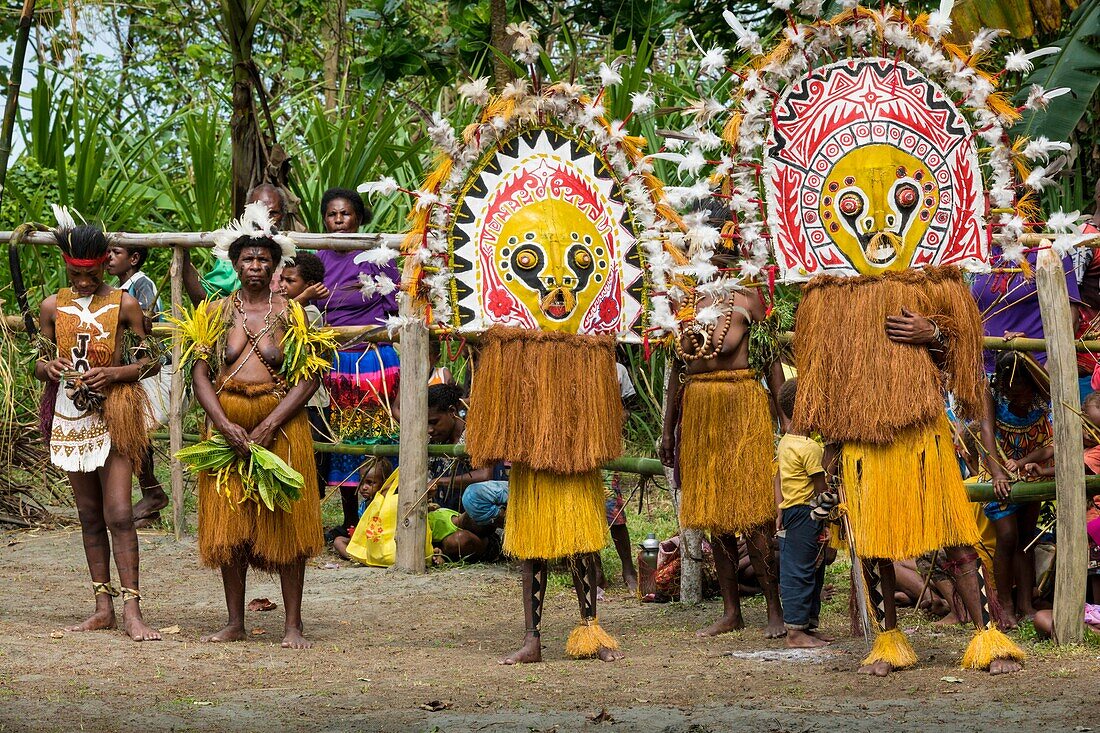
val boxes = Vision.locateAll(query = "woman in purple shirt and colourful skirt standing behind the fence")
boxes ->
[317,188,400,534]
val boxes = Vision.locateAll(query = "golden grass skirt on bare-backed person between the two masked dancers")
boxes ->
[680,369,776,534]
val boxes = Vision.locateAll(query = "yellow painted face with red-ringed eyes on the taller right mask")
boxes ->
[818,144,939,274]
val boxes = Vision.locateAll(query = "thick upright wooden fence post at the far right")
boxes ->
[1035,242,1089,644]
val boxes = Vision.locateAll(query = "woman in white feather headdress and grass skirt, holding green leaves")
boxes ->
[178,205,329,648]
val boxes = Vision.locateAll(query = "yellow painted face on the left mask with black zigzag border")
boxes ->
[496,199,608,332]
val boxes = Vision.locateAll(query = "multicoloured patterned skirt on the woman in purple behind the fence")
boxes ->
[325,343,399,486]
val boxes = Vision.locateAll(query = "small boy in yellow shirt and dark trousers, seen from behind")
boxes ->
[776,379,828,649]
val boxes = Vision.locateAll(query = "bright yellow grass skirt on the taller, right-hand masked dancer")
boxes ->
[842,414,979,560]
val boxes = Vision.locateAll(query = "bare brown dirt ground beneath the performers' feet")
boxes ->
[0,527,1100,733]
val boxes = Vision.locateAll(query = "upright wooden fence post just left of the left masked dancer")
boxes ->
[395,293,428,573]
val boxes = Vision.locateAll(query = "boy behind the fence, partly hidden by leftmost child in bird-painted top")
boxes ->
[107,244,172,521]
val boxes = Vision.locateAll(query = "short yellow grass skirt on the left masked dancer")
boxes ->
[504,463,607,560]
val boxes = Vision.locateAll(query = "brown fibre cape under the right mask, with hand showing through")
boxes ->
[794,266,985,444]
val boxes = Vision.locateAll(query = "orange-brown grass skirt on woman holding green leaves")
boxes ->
[199,381,325,572]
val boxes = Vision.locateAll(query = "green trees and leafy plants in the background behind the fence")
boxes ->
[0,0,1100,453]
